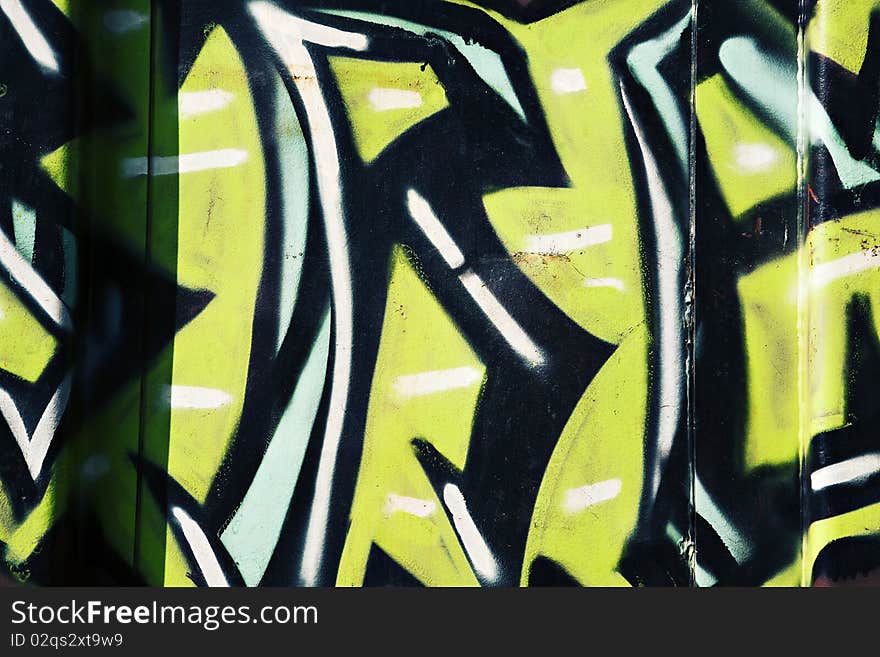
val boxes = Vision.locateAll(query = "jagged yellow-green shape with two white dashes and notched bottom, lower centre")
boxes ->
[337,247,485,586]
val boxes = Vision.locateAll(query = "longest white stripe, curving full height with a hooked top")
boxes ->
[248,1,369,586]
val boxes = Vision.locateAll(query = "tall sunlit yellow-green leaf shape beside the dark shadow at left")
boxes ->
[165,27,266,585]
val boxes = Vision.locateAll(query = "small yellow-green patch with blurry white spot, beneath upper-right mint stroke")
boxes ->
[695,74,797,218]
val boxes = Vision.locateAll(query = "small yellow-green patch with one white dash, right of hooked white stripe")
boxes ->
[329,57,449,162]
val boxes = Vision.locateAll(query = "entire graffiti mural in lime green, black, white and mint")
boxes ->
[0,0,880,586]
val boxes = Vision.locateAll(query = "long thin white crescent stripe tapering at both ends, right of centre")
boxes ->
[620,84,685,496]
